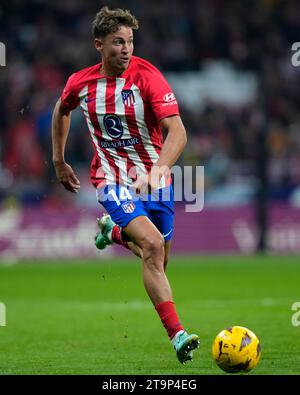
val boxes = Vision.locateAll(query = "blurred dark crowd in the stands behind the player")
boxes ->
[0,0,300,206]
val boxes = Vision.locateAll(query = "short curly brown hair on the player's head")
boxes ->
[92,6,139,38]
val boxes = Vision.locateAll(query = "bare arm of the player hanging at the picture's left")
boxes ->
[52,99,80,193]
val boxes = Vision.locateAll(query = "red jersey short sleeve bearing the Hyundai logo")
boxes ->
[146,68,179,121]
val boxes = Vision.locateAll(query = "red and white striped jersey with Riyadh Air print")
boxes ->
[61,56,179,188]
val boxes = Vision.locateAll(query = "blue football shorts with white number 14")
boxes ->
[96,184,174,241]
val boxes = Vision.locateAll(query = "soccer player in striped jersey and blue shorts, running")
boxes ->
[52,7,199,363]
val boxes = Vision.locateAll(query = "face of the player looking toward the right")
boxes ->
[95,26,133,75]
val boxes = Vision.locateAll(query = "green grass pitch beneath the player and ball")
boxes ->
[0,256,300,375]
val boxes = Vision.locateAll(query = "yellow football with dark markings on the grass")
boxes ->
[212,326,261,373]
